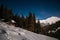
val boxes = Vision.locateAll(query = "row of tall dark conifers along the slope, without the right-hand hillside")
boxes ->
[0,5,41,33]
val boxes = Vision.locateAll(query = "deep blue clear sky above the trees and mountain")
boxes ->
[0,0,60,19]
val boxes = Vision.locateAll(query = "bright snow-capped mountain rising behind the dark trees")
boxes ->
[36,16,60,25]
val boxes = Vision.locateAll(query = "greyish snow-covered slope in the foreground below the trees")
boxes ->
[0,22,58,40]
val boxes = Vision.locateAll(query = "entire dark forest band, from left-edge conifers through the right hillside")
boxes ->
[0,5,60,39]
